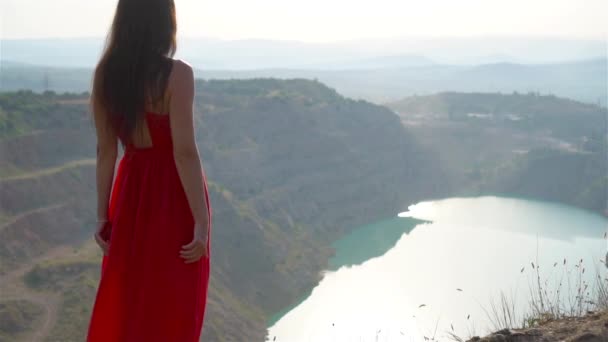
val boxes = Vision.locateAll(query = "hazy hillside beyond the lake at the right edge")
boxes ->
[388,93,608,215]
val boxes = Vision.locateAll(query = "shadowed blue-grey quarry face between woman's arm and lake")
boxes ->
[197,79,449,240]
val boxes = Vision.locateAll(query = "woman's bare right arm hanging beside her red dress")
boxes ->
[169,60,210,262]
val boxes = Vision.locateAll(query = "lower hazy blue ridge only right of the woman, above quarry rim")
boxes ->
[197,58,608,106]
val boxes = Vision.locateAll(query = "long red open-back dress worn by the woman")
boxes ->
[87,113,211,342]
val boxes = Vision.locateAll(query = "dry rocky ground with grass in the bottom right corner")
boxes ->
[469,311,608,342]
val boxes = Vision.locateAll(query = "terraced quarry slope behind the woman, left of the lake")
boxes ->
[0,79,449,341]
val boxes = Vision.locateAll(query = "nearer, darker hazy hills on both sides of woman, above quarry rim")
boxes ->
[0,55,608,107]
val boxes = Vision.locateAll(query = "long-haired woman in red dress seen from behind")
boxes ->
[87,0,211,342]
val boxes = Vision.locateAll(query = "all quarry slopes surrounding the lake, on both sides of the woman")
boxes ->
[0,85,608,341]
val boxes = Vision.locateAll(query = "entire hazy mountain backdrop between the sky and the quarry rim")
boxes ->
[0,37,608,106]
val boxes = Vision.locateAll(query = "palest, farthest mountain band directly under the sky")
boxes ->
[0,37,607,70]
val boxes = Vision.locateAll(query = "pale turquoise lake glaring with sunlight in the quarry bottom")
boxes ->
[268,196,608,342]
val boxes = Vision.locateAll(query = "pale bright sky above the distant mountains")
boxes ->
[0,0,608,42]
